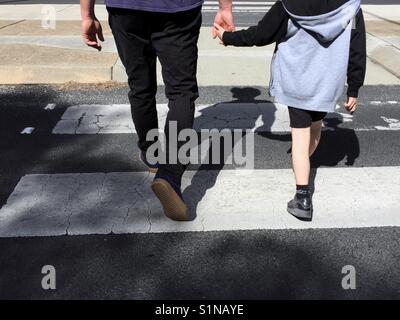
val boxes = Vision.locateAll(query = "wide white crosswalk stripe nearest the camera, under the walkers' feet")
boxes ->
[0,167,400,237]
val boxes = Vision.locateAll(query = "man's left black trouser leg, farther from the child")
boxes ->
[109,8,158,152]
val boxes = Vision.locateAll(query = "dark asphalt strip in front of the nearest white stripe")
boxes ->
[0,228,400,299]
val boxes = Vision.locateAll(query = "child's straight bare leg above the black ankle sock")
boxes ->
[292,127,311,186]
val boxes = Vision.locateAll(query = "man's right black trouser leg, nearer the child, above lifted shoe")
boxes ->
[153,8,201,182]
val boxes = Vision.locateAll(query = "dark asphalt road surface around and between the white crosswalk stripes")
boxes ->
[0,85,400,299]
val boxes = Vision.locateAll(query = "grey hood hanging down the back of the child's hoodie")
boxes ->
[282,0,361,42]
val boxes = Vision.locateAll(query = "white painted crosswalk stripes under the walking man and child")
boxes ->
[0,101,400,237]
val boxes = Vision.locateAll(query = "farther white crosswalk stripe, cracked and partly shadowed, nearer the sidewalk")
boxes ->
[52,103,400,134]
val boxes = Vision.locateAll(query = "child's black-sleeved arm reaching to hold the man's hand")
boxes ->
[215,1,288,47]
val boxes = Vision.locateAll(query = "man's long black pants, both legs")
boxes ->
[107,7,202,181]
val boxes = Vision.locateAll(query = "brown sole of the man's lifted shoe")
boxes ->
[151,179,189,221]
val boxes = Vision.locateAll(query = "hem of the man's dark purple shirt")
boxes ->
[105,0,204,13]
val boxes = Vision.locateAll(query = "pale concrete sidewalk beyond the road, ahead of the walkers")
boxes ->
[0,5,400,86]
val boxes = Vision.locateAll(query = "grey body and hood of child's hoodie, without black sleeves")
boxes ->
[270,0,361,112]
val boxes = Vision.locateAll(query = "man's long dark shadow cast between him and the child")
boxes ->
[183,87,276,220]
